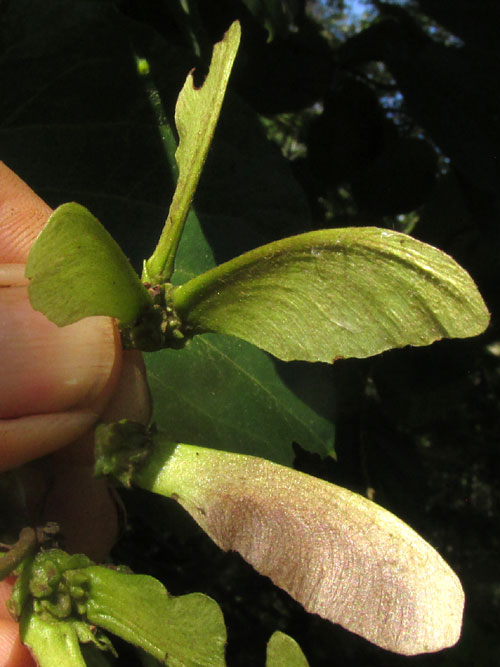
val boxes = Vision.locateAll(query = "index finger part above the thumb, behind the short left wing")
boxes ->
[0,162,52,264]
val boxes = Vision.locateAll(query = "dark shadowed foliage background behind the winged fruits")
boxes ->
[0,0,500,667]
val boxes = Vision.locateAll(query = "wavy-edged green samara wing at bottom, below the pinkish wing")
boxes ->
[83,566,226,667]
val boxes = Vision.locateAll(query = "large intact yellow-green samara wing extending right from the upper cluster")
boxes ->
[174,227,489,362]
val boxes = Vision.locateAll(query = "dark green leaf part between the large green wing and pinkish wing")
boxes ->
[144,334,334,465]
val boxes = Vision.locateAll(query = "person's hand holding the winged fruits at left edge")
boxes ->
[0,163,150,667]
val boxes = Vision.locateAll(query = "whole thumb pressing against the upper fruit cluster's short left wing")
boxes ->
[0,265,121,470]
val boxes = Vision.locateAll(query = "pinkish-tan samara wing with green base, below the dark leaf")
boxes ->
[133,434,464,655]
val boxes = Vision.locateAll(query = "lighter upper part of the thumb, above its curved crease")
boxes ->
[0,287,121,419]
